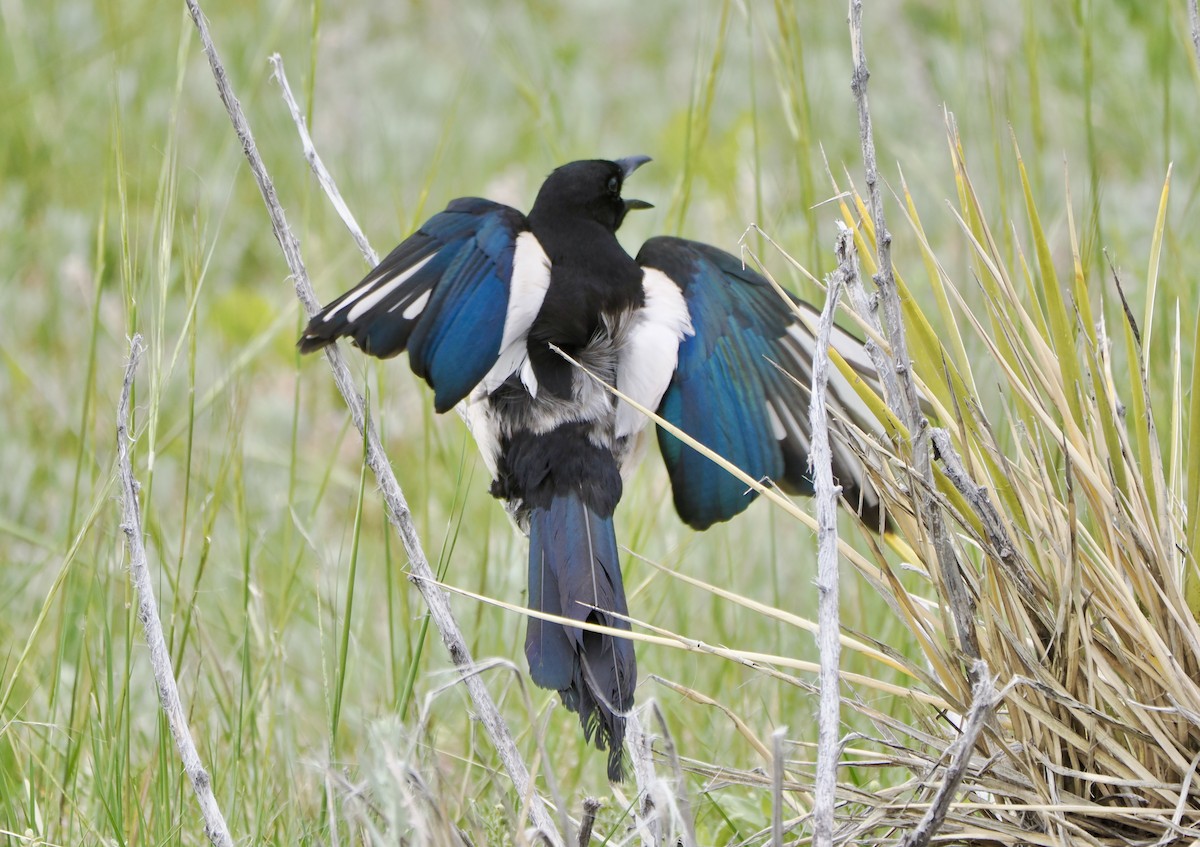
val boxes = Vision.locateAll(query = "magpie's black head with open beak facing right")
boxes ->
[530,156,652,232]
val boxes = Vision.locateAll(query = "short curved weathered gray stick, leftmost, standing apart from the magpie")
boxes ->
[116,335,233,847]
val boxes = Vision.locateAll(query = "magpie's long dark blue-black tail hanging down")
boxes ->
[526,492,637,782]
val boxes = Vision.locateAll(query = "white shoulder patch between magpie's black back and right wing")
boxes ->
[617,268,696,438]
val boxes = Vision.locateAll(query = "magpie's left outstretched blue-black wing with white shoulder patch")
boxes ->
[299,197,550,412]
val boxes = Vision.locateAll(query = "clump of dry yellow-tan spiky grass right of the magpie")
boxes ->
[777,120,1200,845]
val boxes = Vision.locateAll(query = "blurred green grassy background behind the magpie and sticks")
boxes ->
[0,0,1200,845]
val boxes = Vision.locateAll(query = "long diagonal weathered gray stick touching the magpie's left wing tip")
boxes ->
[186,0,563,847]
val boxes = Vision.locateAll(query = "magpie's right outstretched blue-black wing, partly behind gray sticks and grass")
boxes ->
[637,238,883,529]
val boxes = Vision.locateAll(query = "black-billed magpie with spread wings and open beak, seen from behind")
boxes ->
[299,156,884,780]
